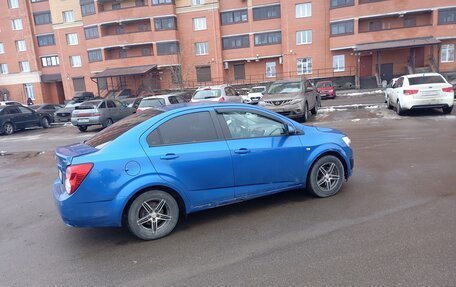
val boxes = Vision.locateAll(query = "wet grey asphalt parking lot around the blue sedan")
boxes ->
[0,96,456,286]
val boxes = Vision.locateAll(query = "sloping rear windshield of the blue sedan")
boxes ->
[85,109,163,148]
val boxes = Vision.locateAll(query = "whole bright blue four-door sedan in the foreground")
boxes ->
[53,104,353,240]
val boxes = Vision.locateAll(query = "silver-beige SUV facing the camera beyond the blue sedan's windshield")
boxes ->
[259,79,320,122]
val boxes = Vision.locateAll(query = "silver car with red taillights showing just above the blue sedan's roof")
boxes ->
[191,85,243,103]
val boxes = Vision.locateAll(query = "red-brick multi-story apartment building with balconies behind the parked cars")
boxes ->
[0,0,456,102]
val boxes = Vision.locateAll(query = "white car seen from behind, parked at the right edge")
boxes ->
[388,73,454,115]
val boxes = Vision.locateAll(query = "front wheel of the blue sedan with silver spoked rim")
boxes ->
[306,155,345,198]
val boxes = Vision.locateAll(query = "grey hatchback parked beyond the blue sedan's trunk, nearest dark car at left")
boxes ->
[71,100,133,132]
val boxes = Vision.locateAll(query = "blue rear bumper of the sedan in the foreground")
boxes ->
[52,179,121,227]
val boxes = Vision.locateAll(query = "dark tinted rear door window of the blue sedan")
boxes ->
[147,112,219,146]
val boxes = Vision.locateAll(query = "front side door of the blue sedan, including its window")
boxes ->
[217,109,306,198]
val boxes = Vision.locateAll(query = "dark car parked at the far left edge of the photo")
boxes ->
[0,105,53,135]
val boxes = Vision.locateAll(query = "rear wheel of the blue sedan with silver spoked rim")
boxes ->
[127,190,179,240]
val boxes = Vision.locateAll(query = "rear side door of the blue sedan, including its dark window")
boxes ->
[145,110,234,209]
